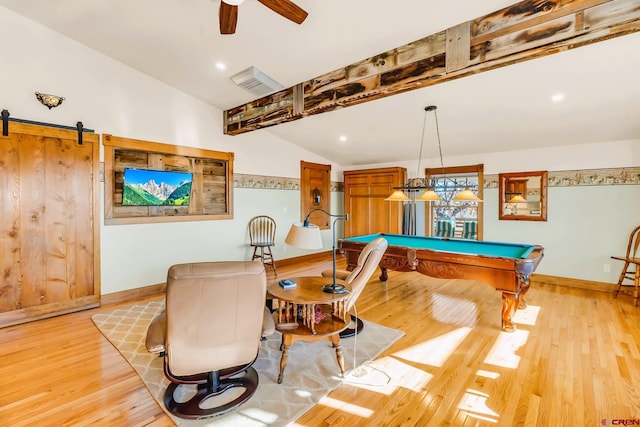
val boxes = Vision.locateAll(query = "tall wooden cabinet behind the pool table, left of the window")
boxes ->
[344,167,407,237]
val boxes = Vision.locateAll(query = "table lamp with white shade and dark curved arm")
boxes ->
[284,209,349,294]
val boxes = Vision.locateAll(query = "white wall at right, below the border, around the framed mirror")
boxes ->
[484,185,640,283]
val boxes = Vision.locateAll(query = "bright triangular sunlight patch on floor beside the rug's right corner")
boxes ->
[394,327,471,367]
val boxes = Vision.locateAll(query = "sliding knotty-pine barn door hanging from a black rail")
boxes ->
[0,122,100,327]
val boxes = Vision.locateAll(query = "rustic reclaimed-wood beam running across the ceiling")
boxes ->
[223,0,640,135]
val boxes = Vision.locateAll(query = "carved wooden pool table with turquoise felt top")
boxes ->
[339,233,544,332]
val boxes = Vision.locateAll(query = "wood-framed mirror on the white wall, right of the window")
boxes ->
[498,171,548,221]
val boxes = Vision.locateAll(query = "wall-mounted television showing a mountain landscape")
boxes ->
[122,168,193,206]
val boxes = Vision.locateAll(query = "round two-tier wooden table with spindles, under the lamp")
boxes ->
[267,276,351,384]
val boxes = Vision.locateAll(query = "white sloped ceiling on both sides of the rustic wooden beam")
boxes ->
[0,0,640,167]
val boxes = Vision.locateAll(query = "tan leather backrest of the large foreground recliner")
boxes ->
[165,260,267,376]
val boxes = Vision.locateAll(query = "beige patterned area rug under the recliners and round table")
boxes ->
[92,301,404,427]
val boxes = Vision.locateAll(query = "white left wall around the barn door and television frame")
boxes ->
[0,7,342,294]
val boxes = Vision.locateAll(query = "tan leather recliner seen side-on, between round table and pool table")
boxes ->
[322,237,389,338]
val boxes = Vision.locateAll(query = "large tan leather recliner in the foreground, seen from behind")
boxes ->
[146,261,274,419]
